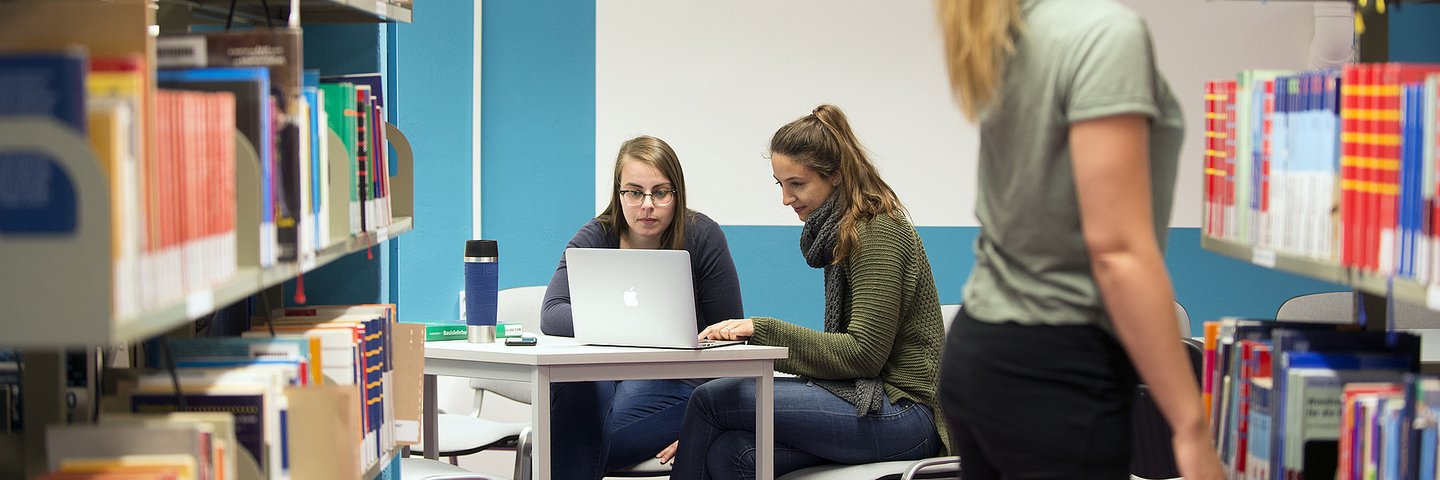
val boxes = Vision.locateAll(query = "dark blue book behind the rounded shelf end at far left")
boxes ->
[0,50,86,235]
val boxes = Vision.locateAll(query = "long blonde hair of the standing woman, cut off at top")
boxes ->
[939,0,1025,120]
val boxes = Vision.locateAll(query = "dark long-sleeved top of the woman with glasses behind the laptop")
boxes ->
[540,210,744,337]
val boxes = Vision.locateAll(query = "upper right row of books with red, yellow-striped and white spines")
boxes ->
[1202,62,1440,281]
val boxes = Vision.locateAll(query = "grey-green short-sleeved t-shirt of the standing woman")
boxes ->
[965,0,1184,330]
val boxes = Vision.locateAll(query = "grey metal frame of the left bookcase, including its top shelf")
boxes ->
[0,0,419,479]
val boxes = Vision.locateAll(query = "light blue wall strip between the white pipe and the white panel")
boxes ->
[480,0,599,294]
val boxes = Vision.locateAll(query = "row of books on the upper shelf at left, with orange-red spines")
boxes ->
[0,29,392,317]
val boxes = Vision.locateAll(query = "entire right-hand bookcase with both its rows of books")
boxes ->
[1201,1,1440,479]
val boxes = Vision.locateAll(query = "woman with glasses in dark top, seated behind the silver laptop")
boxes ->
[540,135,744,479]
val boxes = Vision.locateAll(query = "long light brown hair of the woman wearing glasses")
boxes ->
[596,135,693,249]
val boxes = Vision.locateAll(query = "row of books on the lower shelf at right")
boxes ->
[1201,319,1440,480]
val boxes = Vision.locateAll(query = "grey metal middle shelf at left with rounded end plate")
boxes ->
[0,118,413,347]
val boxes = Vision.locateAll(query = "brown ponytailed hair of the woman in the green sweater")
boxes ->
[770,105,904,264]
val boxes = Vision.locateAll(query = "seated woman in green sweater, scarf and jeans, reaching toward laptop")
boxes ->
[661,105,946,479]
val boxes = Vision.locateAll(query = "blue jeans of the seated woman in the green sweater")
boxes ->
[671,378,940,480]
